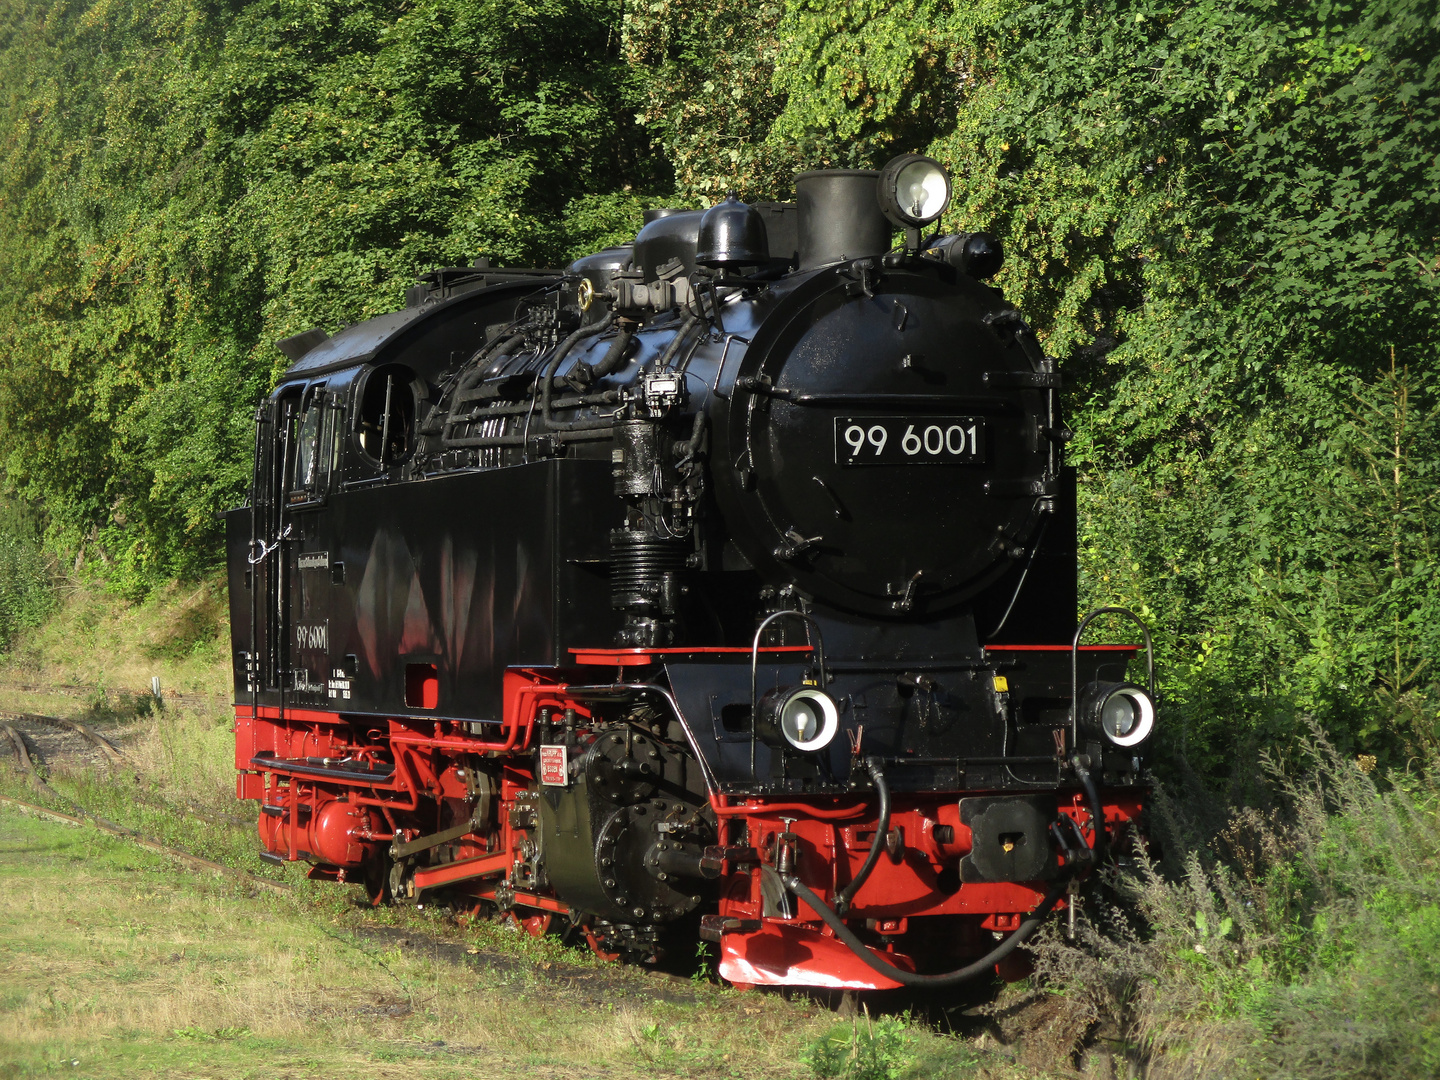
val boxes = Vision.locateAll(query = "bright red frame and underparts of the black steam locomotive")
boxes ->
[235,645,1143,989]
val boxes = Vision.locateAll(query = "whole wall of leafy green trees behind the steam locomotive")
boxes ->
[0,0,1440,768]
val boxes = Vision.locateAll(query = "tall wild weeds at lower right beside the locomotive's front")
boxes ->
[1038,727,1440,1080]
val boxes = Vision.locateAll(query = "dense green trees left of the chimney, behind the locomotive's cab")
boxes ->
[0,0,670,595]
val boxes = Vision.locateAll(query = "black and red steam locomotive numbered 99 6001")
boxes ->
[226,154,1155,989]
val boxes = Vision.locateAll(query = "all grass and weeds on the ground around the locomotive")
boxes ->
[14,586,1440,1080]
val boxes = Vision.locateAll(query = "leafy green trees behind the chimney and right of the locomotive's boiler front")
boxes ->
[628,0,1440,770]
